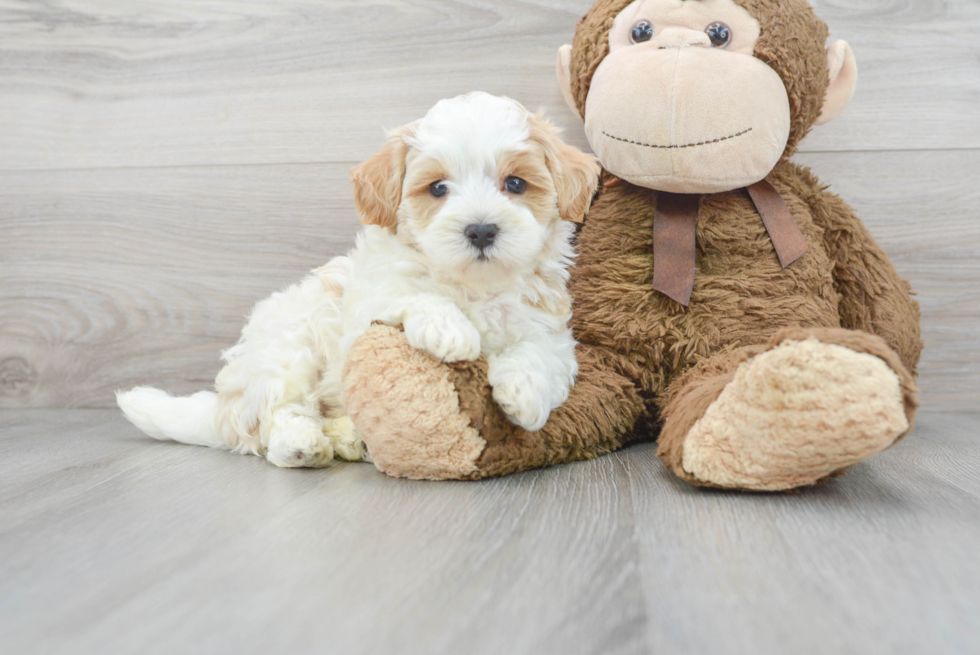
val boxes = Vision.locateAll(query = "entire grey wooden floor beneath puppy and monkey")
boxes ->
[0,410,980,655]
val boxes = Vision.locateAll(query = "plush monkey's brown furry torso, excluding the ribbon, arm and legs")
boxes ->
[570,177,840,395]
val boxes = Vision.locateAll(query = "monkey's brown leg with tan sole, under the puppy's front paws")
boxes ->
[344,325,645,480]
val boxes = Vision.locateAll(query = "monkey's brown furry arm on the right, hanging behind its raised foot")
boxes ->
[800,169,922,375]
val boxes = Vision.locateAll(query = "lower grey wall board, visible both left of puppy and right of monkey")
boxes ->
[0,150,980,411]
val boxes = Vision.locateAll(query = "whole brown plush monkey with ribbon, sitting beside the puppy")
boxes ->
[345,0,921,490]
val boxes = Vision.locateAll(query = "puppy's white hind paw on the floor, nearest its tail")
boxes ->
[266,406,333,468]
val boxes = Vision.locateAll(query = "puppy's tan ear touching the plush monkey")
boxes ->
[528,114,602,223]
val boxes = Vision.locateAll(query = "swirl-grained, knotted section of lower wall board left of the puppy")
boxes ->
[0,165,359,407]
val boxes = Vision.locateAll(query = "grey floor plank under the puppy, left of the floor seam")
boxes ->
[0,411,644,654]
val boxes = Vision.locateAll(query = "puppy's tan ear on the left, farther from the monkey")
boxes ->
[350,123,415,232]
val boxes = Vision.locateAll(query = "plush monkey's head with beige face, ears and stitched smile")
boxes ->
[558,0,857,193]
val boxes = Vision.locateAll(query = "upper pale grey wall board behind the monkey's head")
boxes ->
[0,0,980,170]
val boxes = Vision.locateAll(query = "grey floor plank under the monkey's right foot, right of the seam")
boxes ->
[628,414,980,655]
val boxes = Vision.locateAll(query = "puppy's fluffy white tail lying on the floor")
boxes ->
[116,387,228,449]
